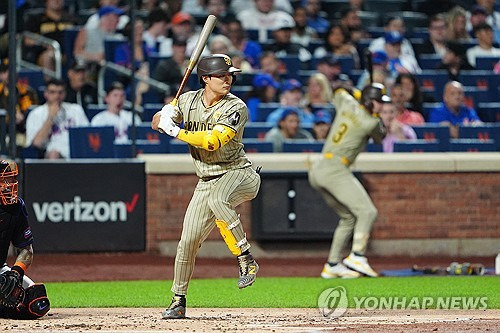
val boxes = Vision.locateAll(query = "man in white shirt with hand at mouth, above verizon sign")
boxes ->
[26,79,89,159]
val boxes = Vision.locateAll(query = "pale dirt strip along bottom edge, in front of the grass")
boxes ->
[0,308,500,333]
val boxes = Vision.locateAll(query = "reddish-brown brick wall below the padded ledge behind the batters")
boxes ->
[146,172,500,252]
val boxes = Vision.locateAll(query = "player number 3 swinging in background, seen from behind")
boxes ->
[309,83,390,279]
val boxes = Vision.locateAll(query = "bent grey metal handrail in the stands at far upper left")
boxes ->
[16,31,62,79]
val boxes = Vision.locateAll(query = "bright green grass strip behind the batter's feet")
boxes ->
[46,276,500,309]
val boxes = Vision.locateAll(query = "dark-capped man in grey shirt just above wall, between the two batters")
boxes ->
[264,107,314,152]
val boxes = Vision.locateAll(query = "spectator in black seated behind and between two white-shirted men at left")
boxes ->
[64,61,97,110]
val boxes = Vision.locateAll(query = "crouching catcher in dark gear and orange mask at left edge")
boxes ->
[0,160,50,319]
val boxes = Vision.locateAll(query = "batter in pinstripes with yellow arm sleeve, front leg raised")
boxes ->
[152,54,260,319]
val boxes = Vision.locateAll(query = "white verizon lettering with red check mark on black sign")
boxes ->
[33,194,139,223]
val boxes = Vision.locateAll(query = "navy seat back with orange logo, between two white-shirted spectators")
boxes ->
[69,126,115,158]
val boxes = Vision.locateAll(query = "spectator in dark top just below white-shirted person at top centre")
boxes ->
[264,14,311,62]
